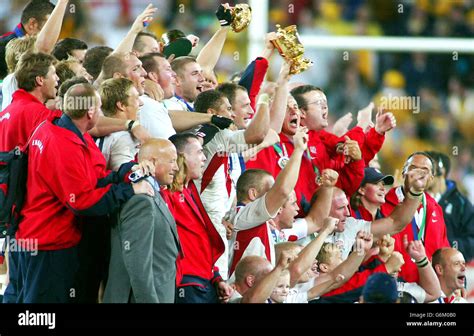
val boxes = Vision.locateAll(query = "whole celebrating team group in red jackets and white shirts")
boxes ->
[0,0,472,303]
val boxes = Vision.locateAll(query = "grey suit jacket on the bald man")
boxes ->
[104,185,181,303]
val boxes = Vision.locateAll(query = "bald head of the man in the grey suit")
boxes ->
[138,139,178,185]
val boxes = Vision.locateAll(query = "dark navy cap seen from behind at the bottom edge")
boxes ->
[362,273,398,303]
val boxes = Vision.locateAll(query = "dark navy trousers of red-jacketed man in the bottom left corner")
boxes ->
[3,247,78,303]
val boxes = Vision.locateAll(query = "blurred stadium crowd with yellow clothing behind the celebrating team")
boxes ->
[0,0,474,202]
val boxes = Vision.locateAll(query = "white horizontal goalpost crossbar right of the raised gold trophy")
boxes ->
[300,35,474,54]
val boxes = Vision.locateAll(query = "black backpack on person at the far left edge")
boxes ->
[0,121,44,238]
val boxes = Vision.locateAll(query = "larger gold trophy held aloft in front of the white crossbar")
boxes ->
[272,24,313,75]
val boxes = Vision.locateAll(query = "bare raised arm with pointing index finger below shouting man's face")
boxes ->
[265,127,308,213]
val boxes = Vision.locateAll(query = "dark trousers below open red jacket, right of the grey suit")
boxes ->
[175,275,219,303]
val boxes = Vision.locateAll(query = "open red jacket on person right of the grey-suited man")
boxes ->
[162,181,225,286]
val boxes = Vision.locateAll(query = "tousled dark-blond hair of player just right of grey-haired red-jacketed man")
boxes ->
[99,78,133,117]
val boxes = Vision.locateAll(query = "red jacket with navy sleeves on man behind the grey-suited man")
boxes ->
[16,115,134,250]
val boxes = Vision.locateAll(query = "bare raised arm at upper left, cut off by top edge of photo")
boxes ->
[35,0,69,54]
